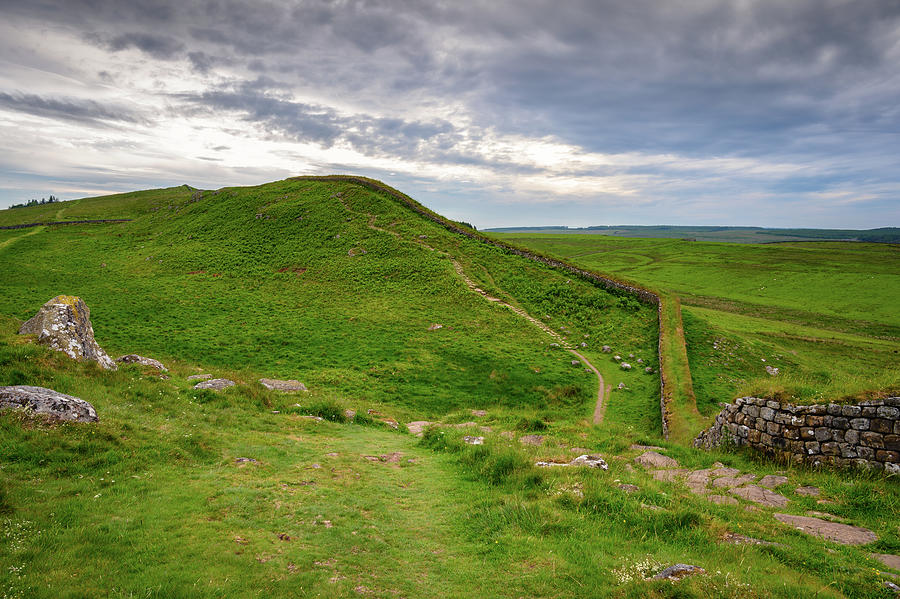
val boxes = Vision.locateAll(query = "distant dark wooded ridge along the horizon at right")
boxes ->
[485,225,900,243]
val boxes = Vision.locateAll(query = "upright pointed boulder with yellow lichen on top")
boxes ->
[19,295,116,370]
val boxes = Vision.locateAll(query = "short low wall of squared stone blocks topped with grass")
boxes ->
[694,397,900,474]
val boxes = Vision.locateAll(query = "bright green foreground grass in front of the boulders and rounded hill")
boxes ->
[0,330,900,597]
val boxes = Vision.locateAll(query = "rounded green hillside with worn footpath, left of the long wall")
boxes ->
[0,181,659,434]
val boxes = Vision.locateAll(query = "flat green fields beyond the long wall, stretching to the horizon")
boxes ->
[492,235,900,414]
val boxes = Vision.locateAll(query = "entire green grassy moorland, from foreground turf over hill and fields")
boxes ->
[0,178,900,597]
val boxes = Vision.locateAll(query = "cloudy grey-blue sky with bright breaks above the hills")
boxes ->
[0,0,900,229]
